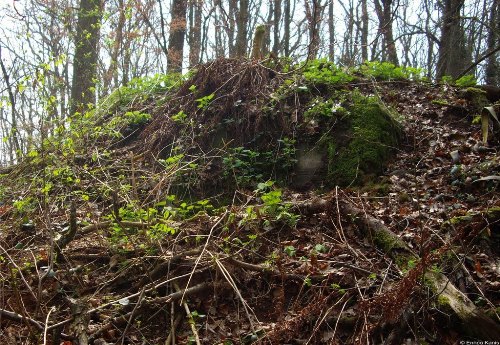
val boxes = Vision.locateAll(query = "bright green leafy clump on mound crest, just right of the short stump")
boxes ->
[303,59,354,85]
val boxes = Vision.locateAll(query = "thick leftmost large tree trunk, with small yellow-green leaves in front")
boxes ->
[70,0,104,115]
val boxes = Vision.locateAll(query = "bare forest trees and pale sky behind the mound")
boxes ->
[0,0,500,164]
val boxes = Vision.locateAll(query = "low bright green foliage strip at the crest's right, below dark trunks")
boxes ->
[359,61,424,81]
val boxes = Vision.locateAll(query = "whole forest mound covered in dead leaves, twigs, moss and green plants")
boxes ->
[0,58,500,345]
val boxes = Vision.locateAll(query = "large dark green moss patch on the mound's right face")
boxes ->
[328,93,401,186]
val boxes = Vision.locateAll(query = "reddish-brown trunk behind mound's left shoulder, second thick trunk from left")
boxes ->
[167,0,187,73]
